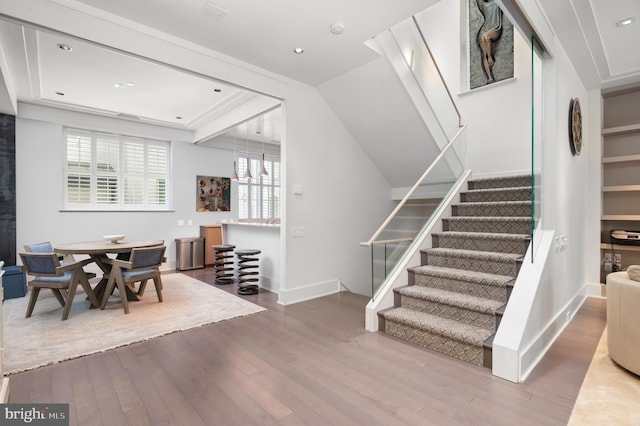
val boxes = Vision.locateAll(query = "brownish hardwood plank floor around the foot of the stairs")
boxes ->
[9,269,606,426]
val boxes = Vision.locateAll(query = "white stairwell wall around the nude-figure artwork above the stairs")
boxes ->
[417,0,531,177]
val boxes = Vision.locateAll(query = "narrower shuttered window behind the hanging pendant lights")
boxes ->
[238,155,280,220]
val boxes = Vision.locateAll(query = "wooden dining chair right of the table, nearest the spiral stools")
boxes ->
[100,246,167,314]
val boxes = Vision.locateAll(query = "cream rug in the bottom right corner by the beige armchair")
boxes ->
[568,328,640,426]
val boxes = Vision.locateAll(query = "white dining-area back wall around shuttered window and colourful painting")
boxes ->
[16,113,237,268]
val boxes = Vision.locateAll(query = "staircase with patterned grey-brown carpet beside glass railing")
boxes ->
[378,176,531,368]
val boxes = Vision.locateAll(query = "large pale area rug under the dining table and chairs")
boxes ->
[3,273,265,374]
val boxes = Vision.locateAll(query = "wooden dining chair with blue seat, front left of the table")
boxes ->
[20,253,99,321]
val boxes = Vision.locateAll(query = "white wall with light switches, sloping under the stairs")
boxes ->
[280,81,391,304]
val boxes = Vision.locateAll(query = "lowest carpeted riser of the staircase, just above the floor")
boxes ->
[384,319,483,366]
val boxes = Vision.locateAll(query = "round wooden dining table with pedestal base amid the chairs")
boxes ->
[54,240,164,307]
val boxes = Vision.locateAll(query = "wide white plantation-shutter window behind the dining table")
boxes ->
[65,129,170,210]
